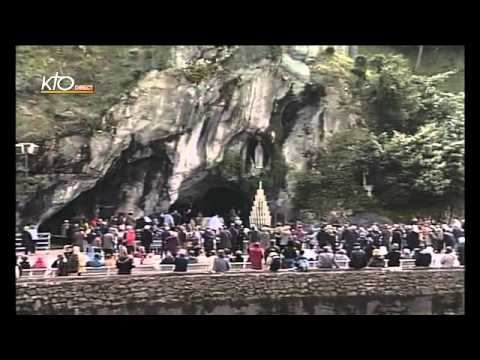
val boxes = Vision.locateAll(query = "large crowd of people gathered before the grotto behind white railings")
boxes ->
[17,209,465,276]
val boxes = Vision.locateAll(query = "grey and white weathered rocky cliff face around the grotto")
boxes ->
[17,46,360,231]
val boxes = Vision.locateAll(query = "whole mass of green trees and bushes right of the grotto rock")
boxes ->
[295,51,465,218]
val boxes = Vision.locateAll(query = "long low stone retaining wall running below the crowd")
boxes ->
[16,269,464,314]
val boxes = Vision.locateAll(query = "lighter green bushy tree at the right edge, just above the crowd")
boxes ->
[377,119,465,208]
